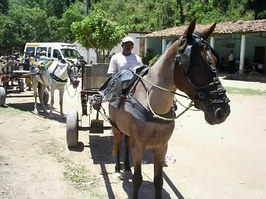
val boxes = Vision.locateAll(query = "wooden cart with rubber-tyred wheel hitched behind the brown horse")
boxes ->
[66,64,111,147]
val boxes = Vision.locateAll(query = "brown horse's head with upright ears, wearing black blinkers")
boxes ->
[174,21,230,124]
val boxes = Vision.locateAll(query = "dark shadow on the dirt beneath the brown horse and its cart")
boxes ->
[85,134,179,199]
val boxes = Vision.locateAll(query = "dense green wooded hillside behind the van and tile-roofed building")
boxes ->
[0,0,266,53]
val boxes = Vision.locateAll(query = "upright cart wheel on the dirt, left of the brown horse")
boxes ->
[66,110,78,147]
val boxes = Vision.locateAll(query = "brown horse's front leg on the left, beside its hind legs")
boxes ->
[132,146,144,199]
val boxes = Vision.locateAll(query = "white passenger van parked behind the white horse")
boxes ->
[24,42,84,63]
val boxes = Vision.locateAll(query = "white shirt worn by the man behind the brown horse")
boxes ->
[107,52,143,74]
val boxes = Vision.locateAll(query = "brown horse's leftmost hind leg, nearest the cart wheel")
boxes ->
[112,127,122,173]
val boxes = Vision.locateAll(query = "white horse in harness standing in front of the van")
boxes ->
[32,60,79,116]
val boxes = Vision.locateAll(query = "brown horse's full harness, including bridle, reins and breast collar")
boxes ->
[101,34,229,125]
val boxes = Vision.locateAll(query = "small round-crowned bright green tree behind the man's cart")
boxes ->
[71,10,126,62]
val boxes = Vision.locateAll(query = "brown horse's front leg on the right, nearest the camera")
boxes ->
[154,145,167,199]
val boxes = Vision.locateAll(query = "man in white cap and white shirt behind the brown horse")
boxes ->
[107,37,143,74]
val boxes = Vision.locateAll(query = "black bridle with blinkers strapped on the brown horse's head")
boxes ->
[174,34,229,104]
